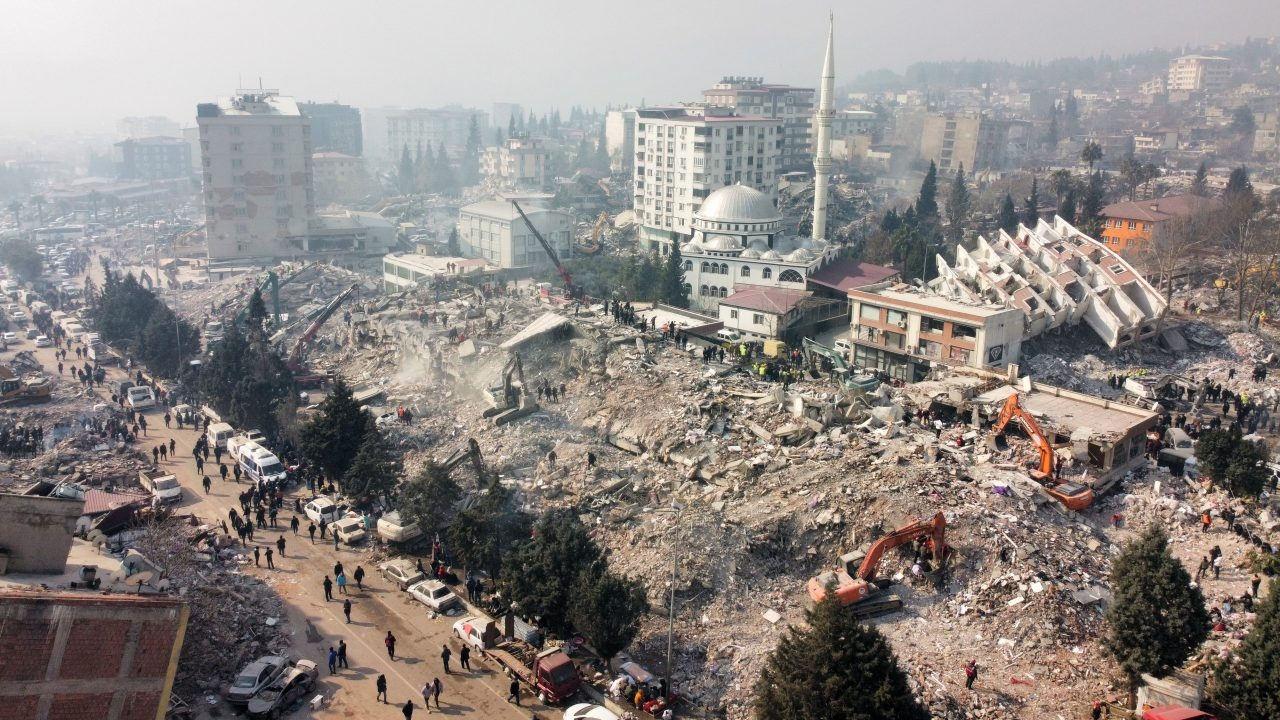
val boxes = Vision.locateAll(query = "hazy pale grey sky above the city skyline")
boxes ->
[0,0,1280,133]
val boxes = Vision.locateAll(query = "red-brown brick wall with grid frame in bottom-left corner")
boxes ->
[0,591,187,720]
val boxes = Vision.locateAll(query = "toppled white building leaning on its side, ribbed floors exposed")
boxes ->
[929,215,1167,348]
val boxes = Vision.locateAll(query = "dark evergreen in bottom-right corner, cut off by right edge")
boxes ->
[1210,579,1280,720]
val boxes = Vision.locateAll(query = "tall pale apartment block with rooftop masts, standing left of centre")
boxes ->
[196,90,315,260]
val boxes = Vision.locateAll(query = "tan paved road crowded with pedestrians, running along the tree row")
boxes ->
[12,275,559,719]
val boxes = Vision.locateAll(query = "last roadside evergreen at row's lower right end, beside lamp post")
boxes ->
[568,562,649,667]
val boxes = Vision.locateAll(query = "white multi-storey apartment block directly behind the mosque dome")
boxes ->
[634,105,785,252]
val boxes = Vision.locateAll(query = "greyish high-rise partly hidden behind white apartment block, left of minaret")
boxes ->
[703,77,814,173]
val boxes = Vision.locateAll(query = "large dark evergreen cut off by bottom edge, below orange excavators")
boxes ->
[755,593,929,720]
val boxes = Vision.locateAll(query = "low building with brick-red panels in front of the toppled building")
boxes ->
[849,283,1023,382]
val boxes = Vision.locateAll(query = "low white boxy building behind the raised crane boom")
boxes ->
[458,199,573,269]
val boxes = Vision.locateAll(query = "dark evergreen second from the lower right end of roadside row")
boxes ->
[500,509,603,637]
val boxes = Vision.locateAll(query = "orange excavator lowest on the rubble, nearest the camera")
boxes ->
[809,512,947,618]
